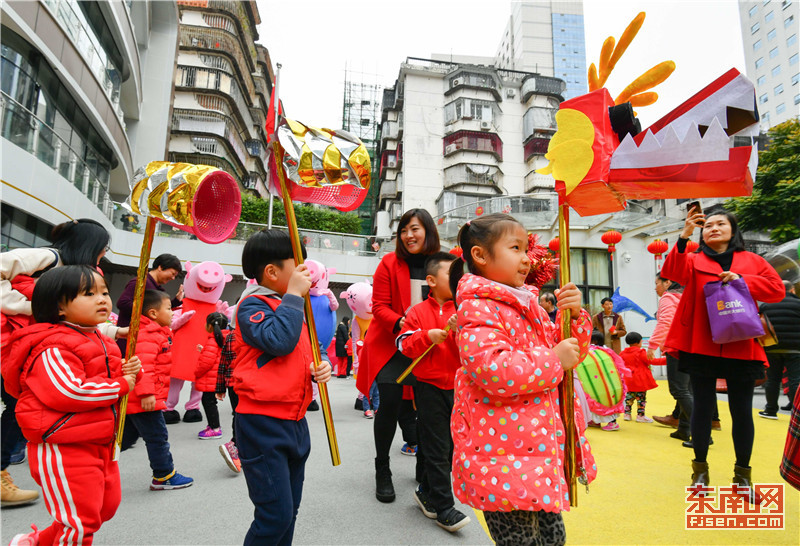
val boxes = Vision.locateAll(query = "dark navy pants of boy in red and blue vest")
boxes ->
[236,413,311,546]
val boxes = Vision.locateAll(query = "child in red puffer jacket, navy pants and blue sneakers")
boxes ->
[122,290,194,491]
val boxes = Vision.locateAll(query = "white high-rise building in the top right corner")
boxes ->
[739,0,800,126]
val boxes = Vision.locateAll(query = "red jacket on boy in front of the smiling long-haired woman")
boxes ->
[397,296,461,390]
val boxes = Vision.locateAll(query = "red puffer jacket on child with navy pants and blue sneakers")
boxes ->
[126,315,172,414]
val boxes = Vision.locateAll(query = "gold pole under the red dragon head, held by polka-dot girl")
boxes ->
[558,200,578,506]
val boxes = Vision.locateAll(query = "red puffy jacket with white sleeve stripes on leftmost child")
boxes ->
[2,323,128,444]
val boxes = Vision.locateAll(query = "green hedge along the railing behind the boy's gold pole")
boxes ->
[241,194,361,234]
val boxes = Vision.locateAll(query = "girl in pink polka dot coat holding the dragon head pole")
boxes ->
[446,214,596,544]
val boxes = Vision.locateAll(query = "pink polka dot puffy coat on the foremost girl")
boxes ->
[450,274,597,512]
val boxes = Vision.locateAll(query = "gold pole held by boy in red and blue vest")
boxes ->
[273,140,342,466]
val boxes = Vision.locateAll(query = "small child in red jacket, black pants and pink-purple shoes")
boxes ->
[194,313,228,440]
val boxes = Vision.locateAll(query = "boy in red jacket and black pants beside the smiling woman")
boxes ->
[397,252,470,532]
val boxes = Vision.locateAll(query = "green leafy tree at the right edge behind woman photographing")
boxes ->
[726,118,800,243]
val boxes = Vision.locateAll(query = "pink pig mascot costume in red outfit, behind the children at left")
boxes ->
[167,262,233,410]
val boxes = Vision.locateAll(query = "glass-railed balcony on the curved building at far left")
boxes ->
[0,94,113,219]
